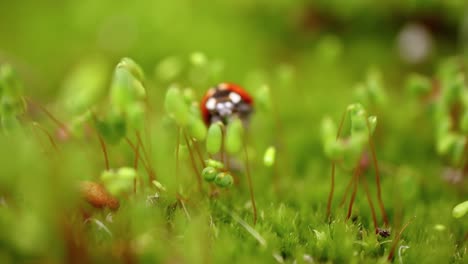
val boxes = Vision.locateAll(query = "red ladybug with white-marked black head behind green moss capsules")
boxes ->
[200,83,253,126]
